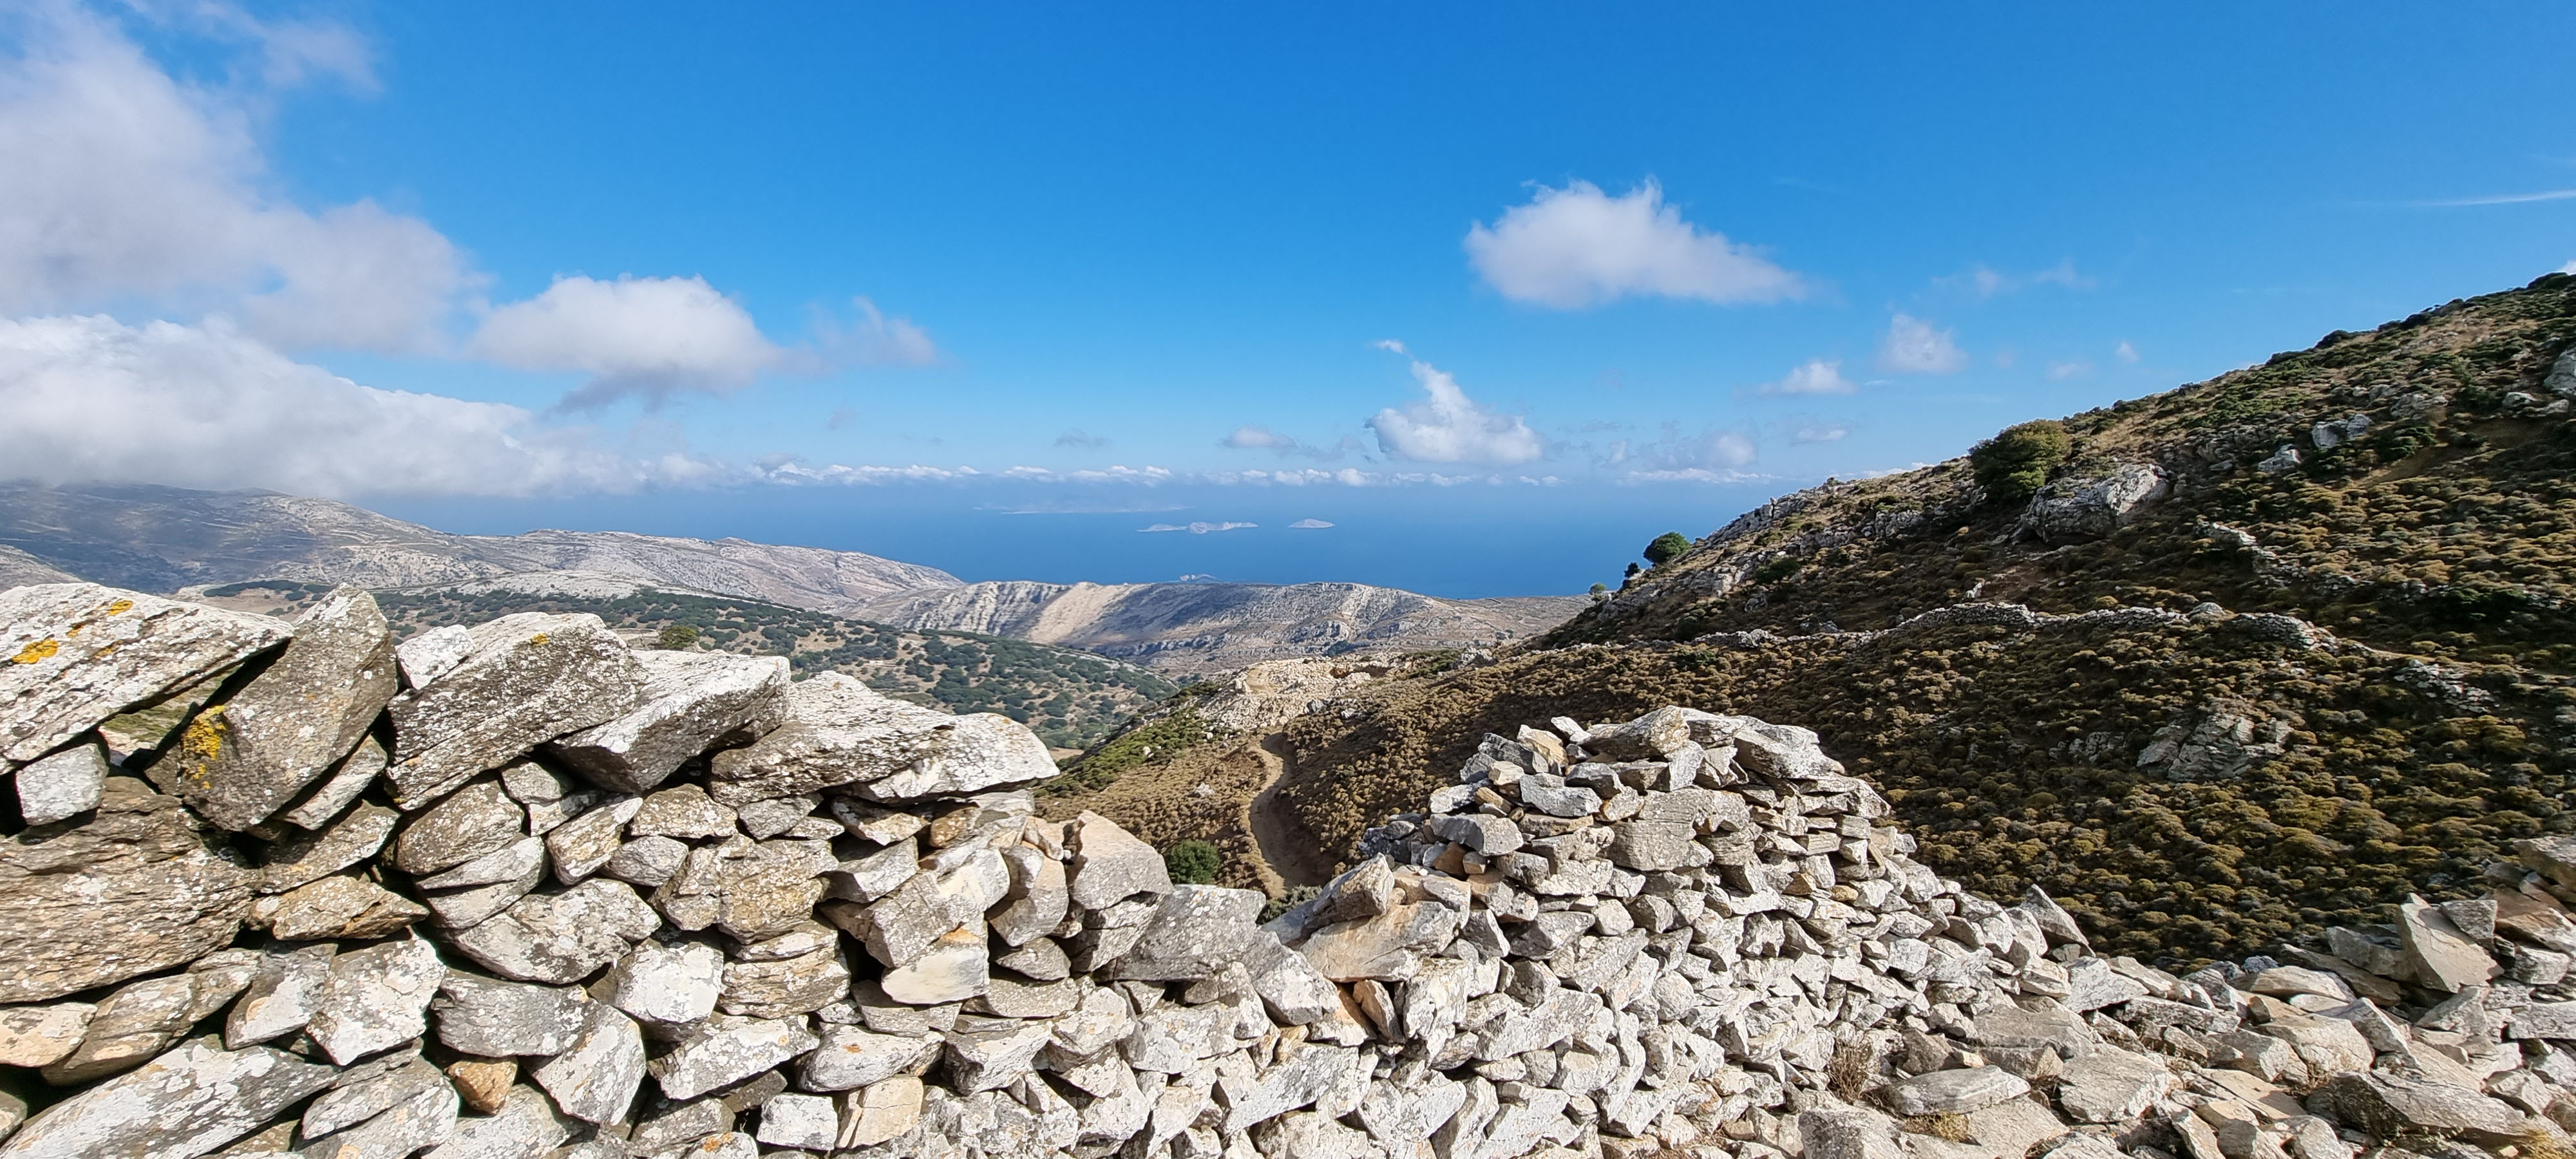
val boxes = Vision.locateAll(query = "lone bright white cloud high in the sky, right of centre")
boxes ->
[1466,180,1806,309]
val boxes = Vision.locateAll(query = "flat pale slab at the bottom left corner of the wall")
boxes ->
[0,1043,335,1159]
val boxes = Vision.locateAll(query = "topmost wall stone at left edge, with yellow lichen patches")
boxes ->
[0,585,289,762]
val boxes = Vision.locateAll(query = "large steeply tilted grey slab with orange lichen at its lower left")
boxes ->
[178,587,397,829]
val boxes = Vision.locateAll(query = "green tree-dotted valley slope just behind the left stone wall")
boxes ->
[196,572,1180,749]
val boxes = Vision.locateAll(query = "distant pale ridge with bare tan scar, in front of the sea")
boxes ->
[863,582,1584,672]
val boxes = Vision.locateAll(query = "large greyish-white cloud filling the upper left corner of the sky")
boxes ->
[0,5,474,353]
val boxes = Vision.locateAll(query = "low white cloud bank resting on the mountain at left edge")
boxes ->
[0,317,696,497]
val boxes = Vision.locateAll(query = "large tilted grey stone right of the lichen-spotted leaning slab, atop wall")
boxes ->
[384,613,647,809]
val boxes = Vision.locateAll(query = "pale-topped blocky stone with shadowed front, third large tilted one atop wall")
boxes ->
[546,652,788,793]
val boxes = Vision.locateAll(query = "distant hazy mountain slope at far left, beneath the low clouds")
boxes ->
[0,484,958,610]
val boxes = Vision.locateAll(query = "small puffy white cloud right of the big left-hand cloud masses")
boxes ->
[466,276,783,407]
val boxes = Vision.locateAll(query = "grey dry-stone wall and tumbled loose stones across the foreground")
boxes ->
[0,585,2576,1159]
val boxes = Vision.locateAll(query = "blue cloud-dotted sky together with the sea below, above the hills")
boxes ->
[0,0,2576,595]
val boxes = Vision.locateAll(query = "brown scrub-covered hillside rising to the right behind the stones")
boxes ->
[1061,276,2576,961]
